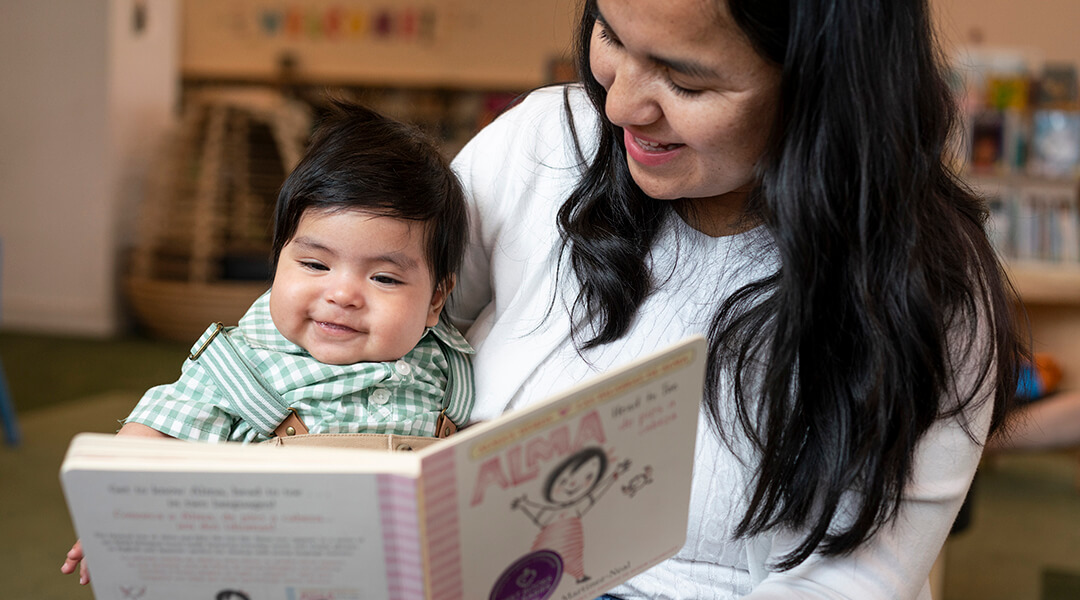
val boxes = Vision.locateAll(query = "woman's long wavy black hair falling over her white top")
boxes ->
[558,0,1023,569]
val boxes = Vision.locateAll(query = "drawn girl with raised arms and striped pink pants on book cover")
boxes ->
[510,446,630,583]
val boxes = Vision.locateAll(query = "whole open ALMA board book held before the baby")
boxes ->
[60,337,705,600]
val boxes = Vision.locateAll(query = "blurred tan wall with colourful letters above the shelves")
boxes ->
[180,0,579,90]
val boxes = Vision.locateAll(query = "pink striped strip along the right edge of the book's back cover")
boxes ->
[377,475,424,600]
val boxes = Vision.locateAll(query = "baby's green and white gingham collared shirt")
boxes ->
[125,291,473,442]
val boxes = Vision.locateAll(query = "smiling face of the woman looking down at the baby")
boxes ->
[590,0,780,235]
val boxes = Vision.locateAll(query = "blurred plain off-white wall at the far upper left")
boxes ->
[0,0,178,335]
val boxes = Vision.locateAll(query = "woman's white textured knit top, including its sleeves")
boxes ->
[449,87,989,600]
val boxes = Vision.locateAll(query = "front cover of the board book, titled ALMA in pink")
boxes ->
[421,338,705,600]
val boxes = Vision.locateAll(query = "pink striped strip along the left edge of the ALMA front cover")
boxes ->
[420,448,464,600]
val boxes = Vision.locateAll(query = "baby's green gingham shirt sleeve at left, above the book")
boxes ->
[124,360,234,441]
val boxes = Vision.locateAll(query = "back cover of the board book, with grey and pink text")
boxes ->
[62,437,419,600]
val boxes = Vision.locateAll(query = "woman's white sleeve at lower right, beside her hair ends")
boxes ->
[745,304,996,600]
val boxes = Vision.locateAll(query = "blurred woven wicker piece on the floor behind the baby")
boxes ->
[124,90,311,341]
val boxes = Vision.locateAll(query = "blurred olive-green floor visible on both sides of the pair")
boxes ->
[0,332,1080,600]
